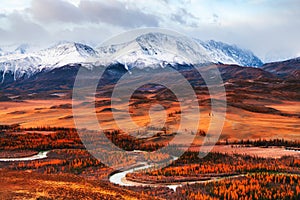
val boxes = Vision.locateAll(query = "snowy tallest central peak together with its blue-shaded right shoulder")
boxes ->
[97,33,263,67]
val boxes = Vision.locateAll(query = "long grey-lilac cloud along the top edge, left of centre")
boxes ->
[30,0,158,28]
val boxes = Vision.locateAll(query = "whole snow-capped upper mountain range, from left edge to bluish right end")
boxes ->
[0,33,262,82]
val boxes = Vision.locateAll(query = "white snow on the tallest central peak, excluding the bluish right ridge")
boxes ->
[97,33,211,68]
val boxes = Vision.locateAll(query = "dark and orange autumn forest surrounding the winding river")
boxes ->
[0,125,300,200]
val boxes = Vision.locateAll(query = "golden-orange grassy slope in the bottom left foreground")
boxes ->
[0,170,158,200]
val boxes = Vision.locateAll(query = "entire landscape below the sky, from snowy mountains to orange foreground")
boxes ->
[0,33,300,200]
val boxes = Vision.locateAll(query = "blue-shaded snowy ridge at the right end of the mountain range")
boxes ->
[198,40,263,67]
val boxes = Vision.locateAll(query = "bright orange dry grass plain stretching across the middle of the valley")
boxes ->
[0,97,300,142]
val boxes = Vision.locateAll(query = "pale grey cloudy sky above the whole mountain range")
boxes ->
[0,0,300,61]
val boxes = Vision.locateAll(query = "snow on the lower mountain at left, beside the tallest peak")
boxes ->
[0,43,97,81]
